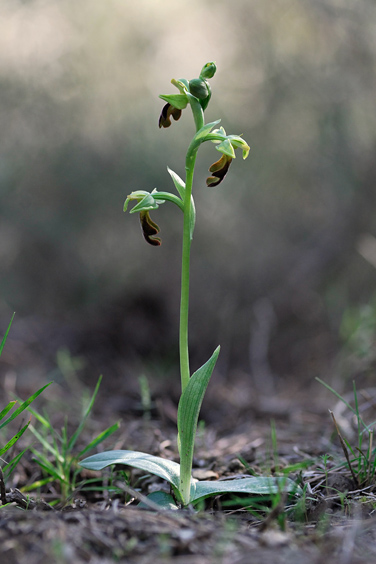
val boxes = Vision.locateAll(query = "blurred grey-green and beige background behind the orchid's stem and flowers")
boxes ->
[0,0,376,406]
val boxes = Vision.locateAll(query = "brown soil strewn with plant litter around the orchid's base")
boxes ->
[0,328,376,564]
